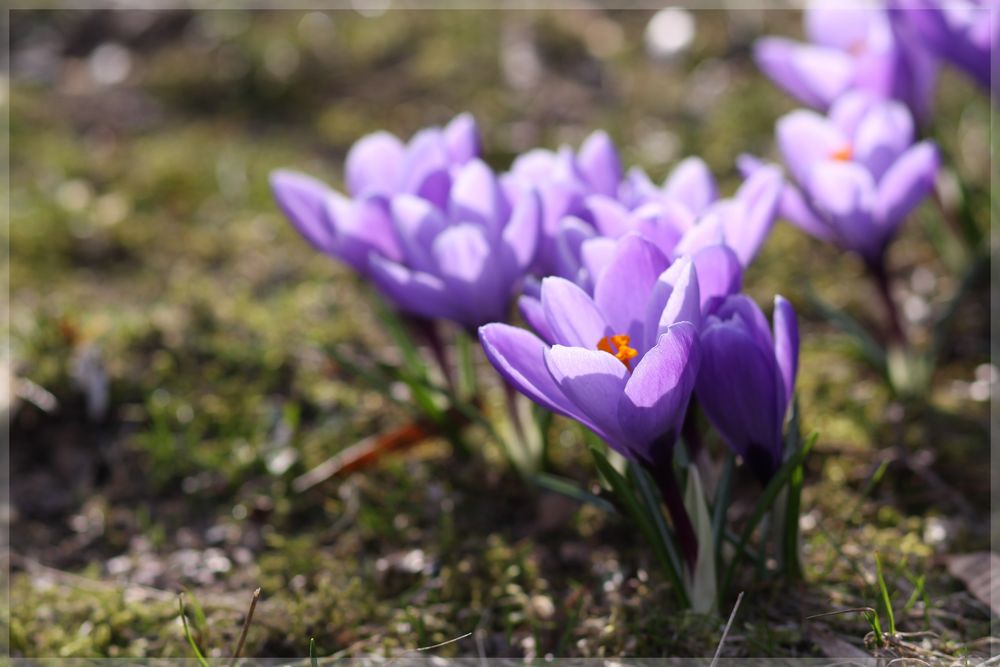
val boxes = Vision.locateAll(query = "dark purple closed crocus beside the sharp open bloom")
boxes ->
[695,294,799,484]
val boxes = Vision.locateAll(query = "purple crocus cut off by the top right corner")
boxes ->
[889,0,1000,90]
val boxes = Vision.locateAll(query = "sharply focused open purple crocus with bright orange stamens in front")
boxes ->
[479,235,701,468]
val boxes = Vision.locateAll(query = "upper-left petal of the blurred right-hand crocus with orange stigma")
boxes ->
[775,109,849,185]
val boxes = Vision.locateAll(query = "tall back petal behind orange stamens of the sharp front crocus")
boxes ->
[592,234,670,344]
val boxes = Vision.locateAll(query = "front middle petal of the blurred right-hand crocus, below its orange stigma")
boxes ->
[807,162,885,261]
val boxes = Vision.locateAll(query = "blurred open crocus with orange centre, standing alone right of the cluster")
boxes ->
[752,92,938,268]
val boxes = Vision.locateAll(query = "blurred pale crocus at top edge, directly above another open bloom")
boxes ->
[754,0,936,118]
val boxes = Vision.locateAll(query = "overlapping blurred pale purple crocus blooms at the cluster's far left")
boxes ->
[271,115,540,329]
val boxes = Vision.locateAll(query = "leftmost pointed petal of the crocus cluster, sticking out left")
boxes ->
[270,169,336,253]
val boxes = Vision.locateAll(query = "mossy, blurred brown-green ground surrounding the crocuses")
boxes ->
[6,4,997,657]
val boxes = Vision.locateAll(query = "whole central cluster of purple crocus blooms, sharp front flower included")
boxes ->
[271,115,798,480]
